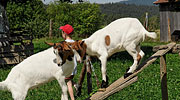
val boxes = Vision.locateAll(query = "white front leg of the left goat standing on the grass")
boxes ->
[55,71,68,100]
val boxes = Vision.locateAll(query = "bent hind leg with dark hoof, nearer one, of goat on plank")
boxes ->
[124,44,138,78]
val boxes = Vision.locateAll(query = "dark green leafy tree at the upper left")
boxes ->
[6,0,49,38]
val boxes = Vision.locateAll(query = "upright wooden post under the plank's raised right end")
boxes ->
[160,54,168,100]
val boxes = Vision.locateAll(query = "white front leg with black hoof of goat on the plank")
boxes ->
[99,55,108,88]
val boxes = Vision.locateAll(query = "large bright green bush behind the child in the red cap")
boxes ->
[47,2,103,37]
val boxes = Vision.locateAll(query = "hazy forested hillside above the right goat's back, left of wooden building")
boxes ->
[99,0,160,31]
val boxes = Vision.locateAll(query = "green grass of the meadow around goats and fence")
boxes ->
[0,39,180,100]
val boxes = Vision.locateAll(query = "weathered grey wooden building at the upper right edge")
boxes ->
[154,0,180,42]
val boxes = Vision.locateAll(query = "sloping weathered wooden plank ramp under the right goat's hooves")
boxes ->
[89,43,176,100]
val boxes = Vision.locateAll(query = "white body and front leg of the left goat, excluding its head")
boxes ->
[0,47,80,100]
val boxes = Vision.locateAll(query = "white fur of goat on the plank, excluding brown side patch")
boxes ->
[83,18,156,82]
